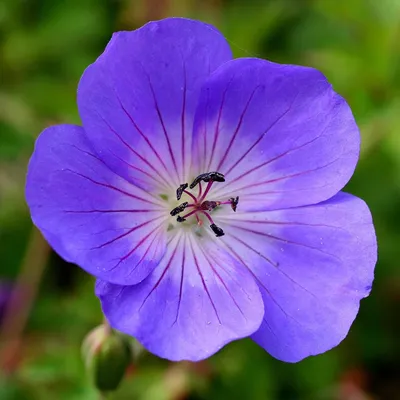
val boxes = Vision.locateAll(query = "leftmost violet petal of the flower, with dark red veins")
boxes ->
[26,125,167,284]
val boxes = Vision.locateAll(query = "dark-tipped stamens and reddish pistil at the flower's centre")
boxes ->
[170,172,239,237]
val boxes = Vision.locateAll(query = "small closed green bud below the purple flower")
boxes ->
[82,325,131,392]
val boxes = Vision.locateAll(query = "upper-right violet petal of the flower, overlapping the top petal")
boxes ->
[193,59,360,210]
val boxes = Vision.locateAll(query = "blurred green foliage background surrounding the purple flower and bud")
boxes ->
[0,0,400,400]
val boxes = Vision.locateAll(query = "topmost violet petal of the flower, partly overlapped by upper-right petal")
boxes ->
[78,18,231,189]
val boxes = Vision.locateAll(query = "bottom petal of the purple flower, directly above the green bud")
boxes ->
[96,230,264,361]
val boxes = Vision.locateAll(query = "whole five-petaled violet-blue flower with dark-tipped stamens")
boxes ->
[26,18,377,362]
